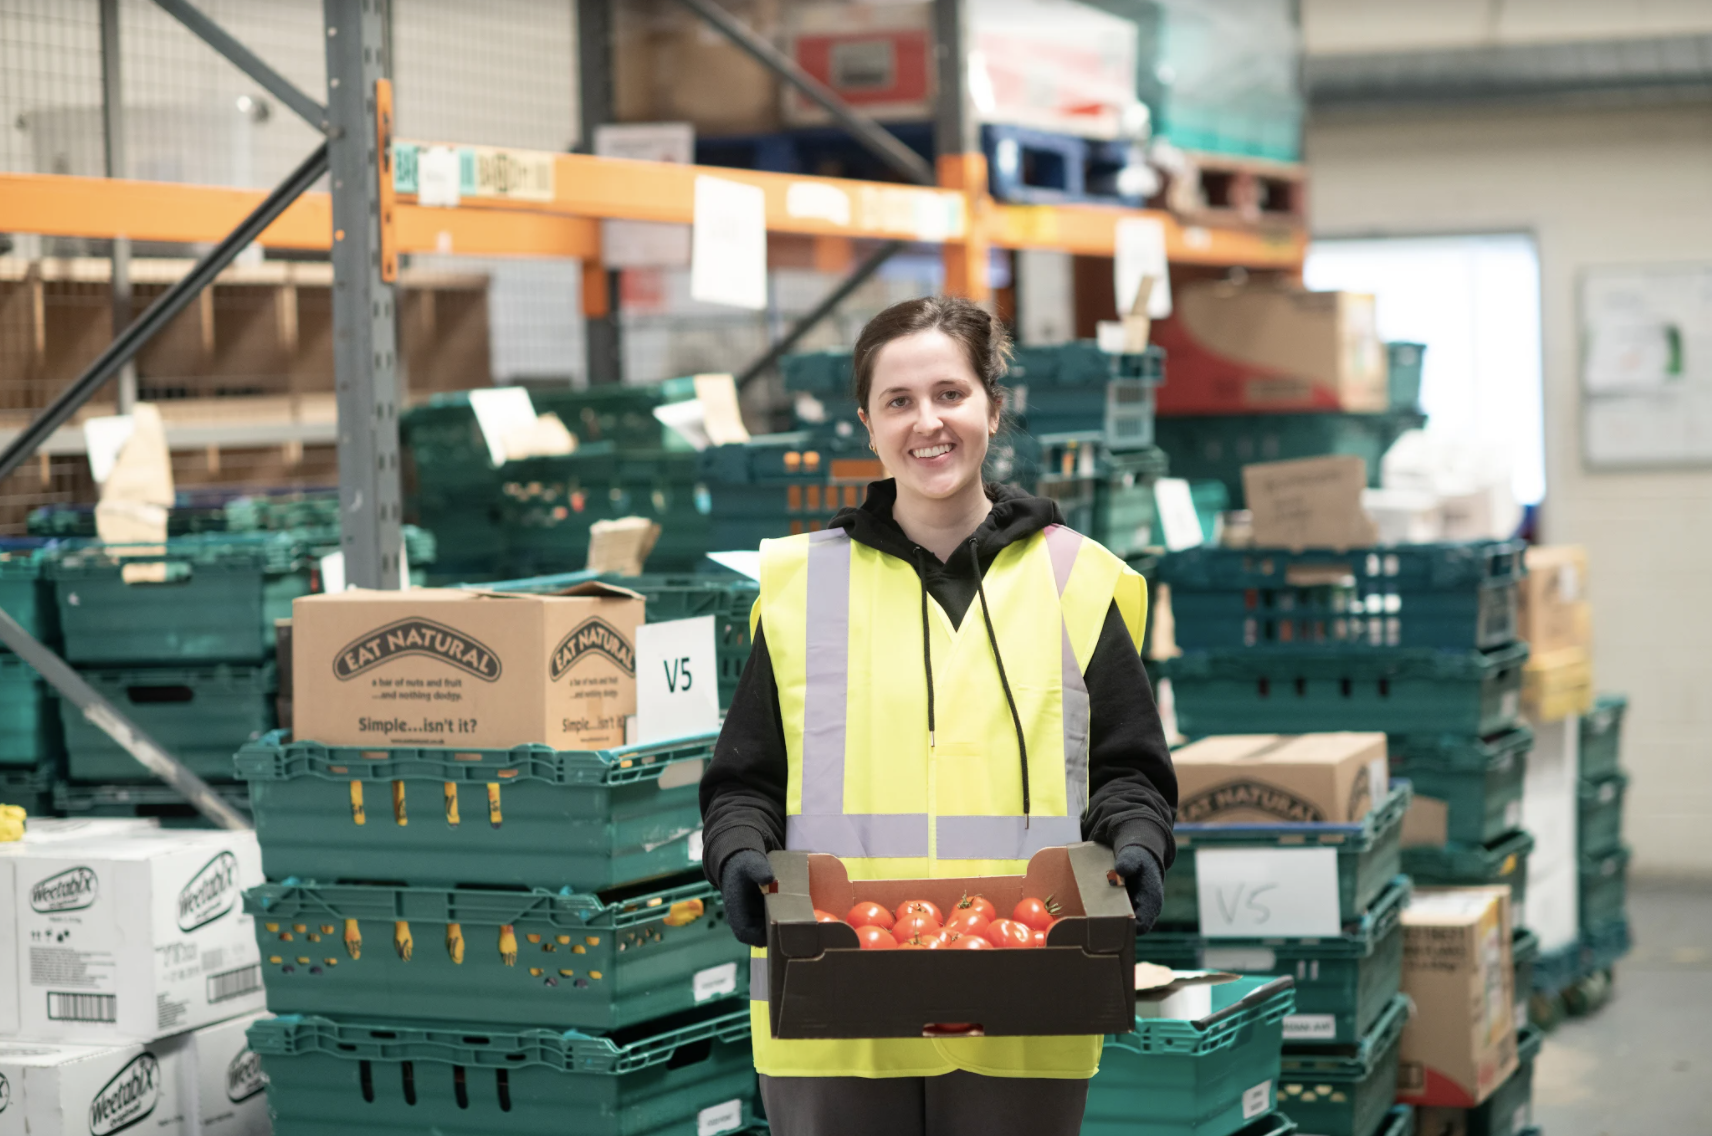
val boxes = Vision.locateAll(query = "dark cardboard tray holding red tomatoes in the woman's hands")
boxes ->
[757,842,1135,1038]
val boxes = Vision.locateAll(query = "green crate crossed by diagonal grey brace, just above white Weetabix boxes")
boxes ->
[58,662,279,782]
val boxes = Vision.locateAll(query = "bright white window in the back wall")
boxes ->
[1305,234,1546,505]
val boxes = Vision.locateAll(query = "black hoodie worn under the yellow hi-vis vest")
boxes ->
[702,481,1176,886]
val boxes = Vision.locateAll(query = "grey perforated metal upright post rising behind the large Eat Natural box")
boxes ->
[322,0,401,589]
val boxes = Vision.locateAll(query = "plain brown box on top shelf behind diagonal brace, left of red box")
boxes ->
[613,0,782,133]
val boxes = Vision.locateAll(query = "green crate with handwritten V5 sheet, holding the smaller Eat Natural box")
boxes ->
[1159,782,1411,929]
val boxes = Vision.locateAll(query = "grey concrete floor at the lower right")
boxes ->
[1534,879,1712,1136]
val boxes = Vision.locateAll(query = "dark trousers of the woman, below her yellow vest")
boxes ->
[760,1071,1087,1136]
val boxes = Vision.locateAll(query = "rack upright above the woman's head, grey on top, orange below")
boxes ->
[933,0,993,303]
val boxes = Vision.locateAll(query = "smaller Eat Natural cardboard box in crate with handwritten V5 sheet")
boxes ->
[1171,734,1390,825]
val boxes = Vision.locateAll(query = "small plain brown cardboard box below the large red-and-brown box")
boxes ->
[1243,455,1378,549]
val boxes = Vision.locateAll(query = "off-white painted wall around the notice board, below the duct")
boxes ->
[1306,99,1712,874]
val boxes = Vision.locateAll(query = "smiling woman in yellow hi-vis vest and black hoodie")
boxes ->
[702,298,1176,1136]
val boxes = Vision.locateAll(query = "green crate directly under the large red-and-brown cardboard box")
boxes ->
[1154,411,1426,508]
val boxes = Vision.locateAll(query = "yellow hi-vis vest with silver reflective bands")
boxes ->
[750,525,1147,1078]
